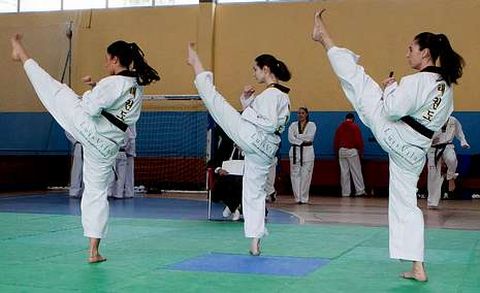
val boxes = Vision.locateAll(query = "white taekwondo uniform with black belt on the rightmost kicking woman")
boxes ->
[327,47,453,262]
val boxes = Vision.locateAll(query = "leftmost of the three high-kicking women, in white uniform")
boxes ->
[11,34,160,263]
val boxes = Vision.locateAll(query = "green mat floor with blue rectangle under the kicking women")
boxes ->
[0,193,480,293]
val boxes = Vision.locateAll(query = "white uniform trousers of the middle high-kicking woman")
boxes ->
[195,72,279,238]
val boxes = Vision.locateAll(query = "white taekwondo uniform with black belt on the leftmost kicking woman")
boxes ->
[24,59,143,238]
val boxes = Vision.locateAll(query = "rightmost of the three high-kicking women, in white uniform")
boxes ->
[312,9,464,282]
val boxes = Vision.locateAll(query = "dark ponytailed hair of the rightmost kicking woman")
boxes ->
[415,32,465,86]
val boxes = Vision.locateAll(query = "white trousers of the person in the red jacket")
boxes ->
[338,148,365,196]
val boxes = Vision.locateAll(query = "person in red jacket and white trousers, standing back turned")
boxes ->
[334,113,365,196]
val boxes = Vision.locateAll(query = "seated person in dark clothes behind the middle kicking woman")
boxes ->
[207,126,243,221]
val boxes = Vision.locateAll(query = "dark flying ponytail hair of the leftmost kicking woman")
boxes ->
[107,40,160,85]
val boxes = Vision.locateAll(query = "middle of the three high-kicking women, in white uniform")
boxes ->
[188,44,290,256]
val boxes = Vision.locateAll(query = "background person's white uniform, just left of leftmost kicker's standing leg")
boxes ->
[65,131,83,198]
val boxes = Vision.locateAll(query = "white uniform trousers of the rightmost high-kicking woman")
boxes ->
[327,47,431,261]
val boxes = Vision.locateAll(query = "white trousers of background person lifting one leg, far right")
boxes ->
[427,144,458,207]
